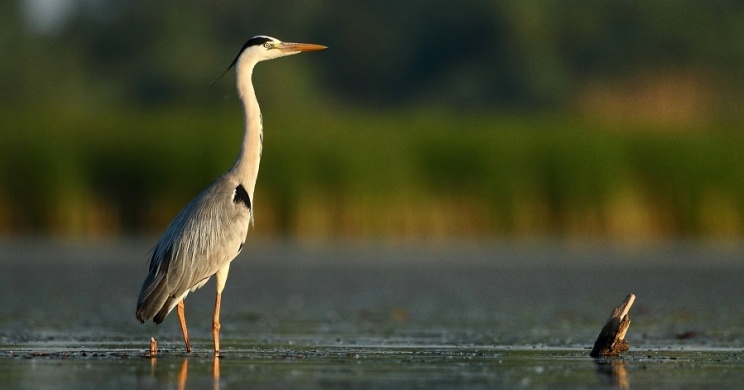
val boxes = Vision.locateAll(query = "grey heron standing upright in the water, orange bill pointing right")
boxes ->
[137,35,326,354]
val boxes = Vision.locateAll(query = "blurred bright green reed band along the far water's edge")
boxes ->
[0,107,744,239]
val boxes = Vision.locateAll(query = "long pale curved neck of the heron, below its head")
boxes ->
[230,59,263,199]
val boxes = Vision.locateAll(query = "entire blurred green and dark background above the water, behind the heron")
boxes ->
[0,0,744,242]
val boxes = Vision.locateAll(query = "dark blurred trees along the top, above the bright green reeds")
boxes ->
[0,0,744,110]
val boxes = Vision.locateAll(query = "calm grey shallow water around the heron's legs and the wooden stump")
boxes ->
[0,240,744,389]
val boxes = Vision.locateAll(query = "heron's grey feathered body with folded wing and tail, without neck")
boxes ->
[137,175,252,324]
